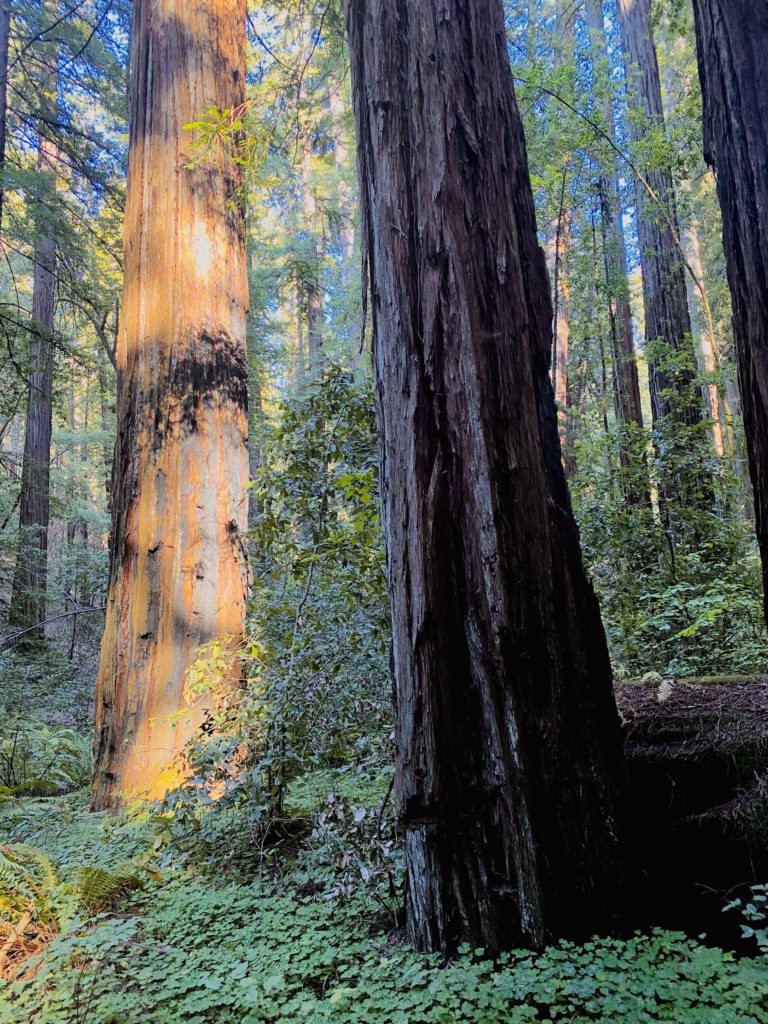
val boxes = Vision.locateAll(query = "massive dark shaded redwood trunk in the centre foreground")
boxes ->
[345,0,621,950]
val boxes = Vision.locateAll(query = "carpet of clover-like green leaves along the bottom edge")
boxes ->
[7,880,768,1024]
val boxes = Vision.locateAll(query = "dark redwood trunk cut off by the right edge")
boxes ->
[693,0,768,617]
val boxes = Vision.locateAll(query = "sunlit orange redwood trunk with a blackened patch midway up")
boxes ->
[93,0,248,807]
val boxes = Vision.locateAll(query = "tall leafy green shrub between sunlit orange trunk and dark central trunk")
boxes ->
[155,367,392,861]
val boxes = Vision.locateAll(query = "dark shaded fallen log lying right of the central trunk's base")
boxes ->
[617,678,768,947]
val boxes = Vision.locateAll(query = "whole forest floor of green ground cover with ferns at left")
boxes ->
[0,659,768,1024]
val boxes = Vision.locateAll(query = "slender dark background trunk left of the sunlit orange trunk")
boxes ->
[8,94,58,640]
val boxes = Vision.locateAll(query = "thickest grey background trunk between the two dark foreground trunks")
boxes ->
[618,0,701,425]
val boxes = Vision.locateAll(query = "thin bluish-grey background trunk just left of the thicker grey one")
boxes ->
[587,0,643,436]
